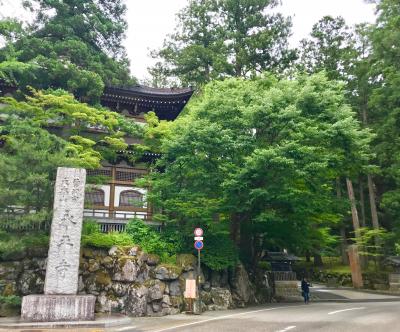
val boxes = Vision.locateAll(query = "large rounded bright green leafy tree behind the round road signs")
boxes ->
[145,74,370,266]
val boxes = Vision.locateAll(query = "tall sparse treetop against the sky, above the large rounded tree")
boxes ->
[152,0,295,85]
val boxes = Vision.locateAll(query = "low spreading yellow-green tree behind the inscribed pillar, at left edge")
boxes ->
[0,90,141,226]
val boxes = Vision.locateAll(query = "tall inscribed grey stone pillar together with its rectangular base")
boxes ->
[21,167,96,322]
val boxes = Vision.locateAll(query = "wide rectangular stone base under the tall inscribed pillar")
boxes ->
[21,295,96,322]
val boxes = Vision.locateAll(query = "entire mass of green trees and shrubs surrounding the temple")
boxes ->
[0,0,400,270]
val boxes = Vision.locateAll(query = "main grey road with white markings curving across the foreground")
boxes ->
[108,302,400,332]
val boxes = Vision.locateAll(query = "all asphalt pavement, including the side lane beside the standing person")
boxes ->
[4,285,400,332]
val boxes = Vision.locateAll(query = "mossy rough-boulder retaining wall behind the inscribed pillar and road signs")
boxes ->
[0,246,271,316]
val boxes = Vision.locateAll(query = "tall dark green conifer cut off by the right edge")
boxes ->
[369,0,400,233]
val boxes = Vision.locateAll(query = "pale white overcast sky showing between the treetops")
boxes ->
[0,0,374,79]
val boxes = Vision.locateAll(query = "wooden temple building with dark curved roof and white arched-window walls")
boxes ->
[0,81,194,232]
